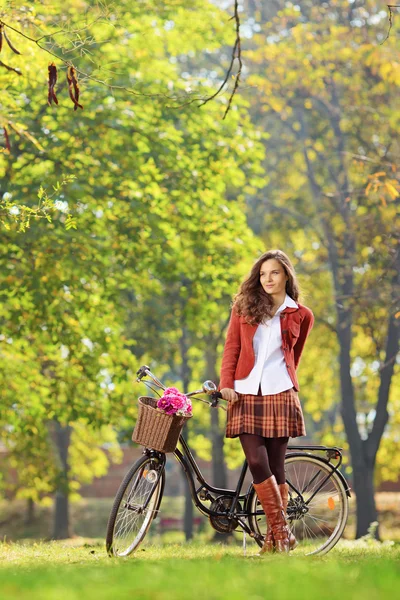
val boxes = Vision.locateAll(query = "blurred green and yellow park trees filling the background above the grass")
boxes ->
[0,0,400,542]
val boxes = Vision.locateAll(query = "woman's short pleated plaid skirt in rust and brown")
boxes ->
[225,388,306,438]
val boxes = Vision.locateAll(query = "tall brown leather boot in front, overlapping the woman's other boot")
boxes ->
[253,475,289,554]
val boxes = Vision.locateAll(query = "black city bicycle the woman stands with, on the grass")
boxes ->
[106,365,351,556]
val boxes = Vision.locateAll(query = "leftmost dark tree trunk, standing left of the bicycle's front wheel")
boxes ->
[53,421,71,540]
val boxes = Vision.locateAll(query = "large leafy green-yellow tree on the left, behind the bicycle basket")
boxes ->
[0,3,268,537]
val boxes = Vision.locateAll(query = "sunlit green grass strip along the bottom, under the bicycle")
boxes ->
[0,539,400,600]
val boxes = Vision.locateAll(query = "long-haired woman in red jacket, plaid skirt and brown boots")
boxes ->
[218,250,314,554]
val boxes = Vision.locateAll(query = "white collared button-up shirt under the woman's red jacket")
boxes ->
[234,294,298,396]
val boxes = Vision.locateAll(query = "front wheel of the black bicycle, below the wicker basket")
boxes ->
[106,454,165,556]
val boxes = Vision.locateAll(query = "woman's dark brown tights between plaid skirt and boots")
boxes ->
[239,433,289,484]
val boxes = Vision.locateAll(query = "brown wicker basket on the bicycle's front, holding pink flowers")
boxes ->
[132,396,191,452]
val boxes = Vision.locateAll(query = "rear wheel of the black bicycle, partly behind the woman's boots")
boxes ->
[249,454,348,555]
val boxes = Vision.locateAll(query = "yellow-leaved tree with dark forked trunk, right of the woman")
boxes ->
[242,2,400,537]
